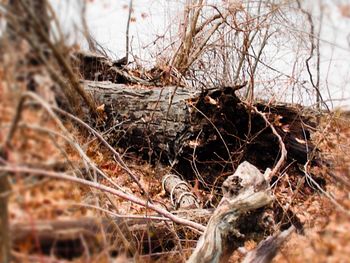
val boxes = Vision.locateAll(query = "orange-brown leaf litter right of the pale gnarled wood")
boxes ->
[274,115,350,262]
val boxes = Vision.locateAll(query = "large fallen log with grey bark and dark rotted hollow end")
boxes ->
[84,81,314,186]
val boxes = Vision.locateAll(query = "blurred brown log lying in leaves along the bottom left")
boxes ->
[10,218,181,258]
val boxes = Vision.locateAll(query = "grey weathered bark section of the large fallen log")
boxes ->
[84,81,198,162]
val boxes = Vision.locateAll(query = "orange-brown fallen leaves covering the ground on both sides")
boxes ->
[0,60,350,262]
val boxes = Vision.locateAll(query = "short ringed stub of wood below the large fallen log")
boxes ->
[162,174,199,209]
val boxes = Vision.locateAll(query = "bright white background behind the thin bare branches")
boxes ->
[51,0,350,109]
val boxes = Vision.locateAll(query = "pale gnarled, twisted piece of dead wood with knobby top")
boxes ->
[188,162,272,263]
